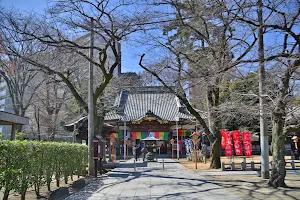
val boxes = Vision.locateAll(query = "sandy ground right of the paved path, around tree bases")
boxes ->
[179,156,300,200]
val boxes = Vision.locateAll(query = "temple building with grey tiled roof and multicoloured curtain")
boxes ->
[105,86,195,153]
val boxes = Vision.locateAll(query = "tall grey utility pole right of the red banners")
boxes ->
[257,0,270,179]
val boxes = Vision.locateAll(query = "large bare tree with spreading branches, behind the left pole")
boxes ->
[1,0,155,174]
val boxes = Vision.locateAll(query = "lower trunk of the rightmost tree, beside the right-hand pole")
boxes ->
[268,101,287,188]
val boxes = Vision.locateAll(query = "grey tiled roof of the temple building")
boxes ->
[105,87,193,121]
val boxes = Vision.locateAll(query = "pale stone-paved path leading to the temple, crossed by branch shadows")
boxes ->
[67,159,239,200]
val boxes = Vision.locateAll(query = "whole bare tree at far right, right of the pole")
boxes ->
[237,1,300,187]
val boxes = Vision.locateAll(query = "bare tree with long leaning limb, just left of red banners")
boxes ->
[140,1,257,168]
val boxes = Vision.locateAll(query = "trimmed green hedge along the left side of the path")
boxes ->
[0,140,88,199]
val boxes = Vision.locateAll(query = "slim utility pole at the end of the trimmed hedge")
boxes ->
[88,18,95,176]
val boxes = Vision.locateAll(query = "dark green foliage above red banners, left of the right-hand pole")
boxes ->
[218,72,259,131]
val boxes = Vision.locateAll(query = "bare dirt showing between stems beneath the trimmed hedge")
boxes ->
[0,176,83,200]
